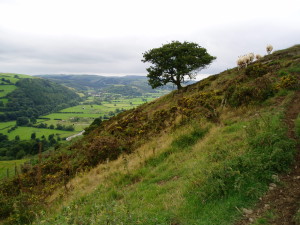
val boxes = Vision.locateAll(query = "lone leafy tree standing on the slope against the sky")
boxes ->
[142,41,216,90]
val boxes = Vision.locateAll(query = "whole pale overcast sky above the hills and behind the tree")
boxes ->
[0,0,300,78]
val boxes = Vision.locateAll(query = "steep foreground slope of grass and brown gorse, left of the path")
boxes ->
[0,45,300,224]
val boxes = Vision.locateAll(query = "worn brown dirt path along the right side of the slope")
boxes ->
[236,91,300,225]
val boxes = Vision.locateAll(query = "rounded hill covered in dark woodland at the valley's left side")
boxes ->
[0,74,79,121]
